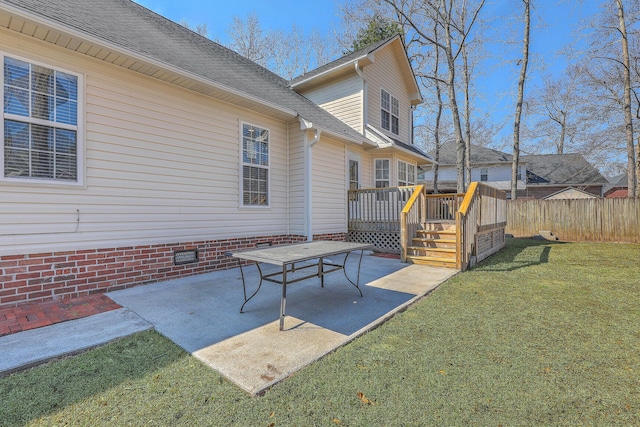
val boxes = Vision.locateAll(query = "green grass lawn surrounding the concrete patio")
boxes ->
[0,240,640,427]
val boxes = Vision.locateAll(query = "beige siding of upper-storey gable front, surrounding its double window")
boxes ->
[364,49,411,143]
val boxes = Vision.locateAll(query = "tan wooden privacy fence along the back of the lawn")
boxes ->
[505,198,640,243]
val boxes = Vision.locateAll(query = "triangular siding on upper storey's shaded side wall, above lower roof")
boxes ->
[303,75,363,132]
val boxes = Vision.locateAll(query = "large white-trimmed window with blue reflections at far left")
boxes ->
[2,56,82,182]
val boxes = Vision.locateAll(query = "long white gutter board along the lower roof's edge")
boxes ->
[0,4,298,118]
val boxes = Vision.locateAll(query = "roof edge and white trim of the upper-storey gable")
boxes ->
[290,35,423,105]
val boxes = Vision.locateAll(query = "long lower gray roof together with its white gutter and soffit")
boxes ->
[0,0,375,145]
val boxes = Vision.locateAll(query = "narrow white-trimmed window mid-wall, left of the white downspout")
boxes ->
[242,123,269,206]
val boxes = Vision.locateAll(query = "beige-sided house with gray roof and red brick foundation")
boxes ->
[0,0,432,307]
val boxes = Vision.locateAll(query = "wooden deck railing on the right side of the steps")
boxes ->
[456,182,507,270]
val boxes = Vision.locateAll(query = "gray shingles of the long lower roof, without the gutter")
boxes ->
[4,0,366,141]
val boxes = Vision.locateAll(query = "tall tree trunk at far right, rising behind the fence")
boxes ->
[616,0,638,197]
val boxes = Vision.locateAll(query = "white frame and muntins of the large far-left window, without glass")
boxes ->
[0,51,85,187]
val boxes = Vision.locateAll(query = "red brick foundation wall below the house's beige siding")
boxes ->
[0,233,306,307]
